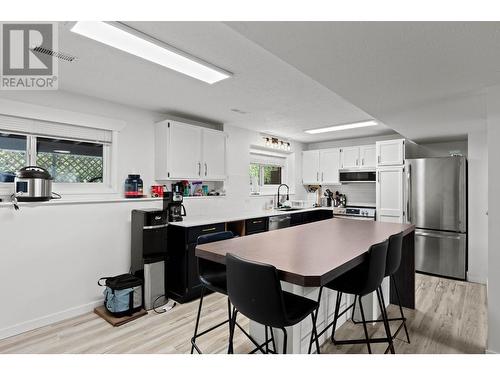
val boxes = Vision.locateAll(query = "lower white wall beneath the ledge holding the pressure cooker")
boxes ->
[0,198,161,338]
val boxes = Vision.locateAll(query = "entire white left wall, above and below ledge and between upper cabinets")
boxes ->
[0,91,304,338]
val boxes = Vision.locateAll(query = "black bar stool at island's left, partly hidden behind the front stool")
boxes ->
[191,231,259,354]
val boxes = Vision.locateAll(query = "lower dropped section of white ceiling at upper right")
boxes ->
[227,22,500,140]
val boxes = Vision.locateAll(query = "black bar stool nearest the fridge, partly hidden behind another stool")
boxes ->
[352,232,410,344]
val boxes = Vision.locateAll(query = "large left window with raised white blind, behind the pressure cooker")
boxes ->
[0,115,116,195]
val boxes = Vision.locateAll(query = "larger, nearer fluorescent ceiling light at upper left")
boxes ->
[71,21,232,84]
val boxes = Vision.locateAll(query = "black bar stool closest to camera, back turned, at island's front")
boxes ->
[226,254,319,354]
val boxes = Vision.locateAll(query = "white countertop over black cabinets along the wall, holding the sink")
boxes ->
[169,207,332,227]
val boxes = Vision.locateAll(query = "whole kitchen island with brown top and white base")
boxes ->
[196,218,415,353]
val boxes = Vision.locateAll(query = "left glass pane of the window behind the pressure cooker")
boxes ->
[0,133,27,182]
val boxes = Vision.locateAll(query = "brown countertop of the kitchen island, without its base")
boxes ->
[196,218,415,286]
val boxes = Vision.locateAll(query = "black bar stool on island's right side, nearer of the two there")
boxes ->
[309,240,395,354]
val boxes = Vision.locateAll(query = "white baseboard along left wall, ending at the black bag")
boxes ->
[0,299,102,339]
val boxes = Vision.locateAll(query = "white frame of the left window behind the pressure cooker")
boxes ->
[0,129,118,196]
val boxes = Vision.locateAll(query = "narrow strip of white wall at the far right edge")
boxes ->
[487,86,500,353]
